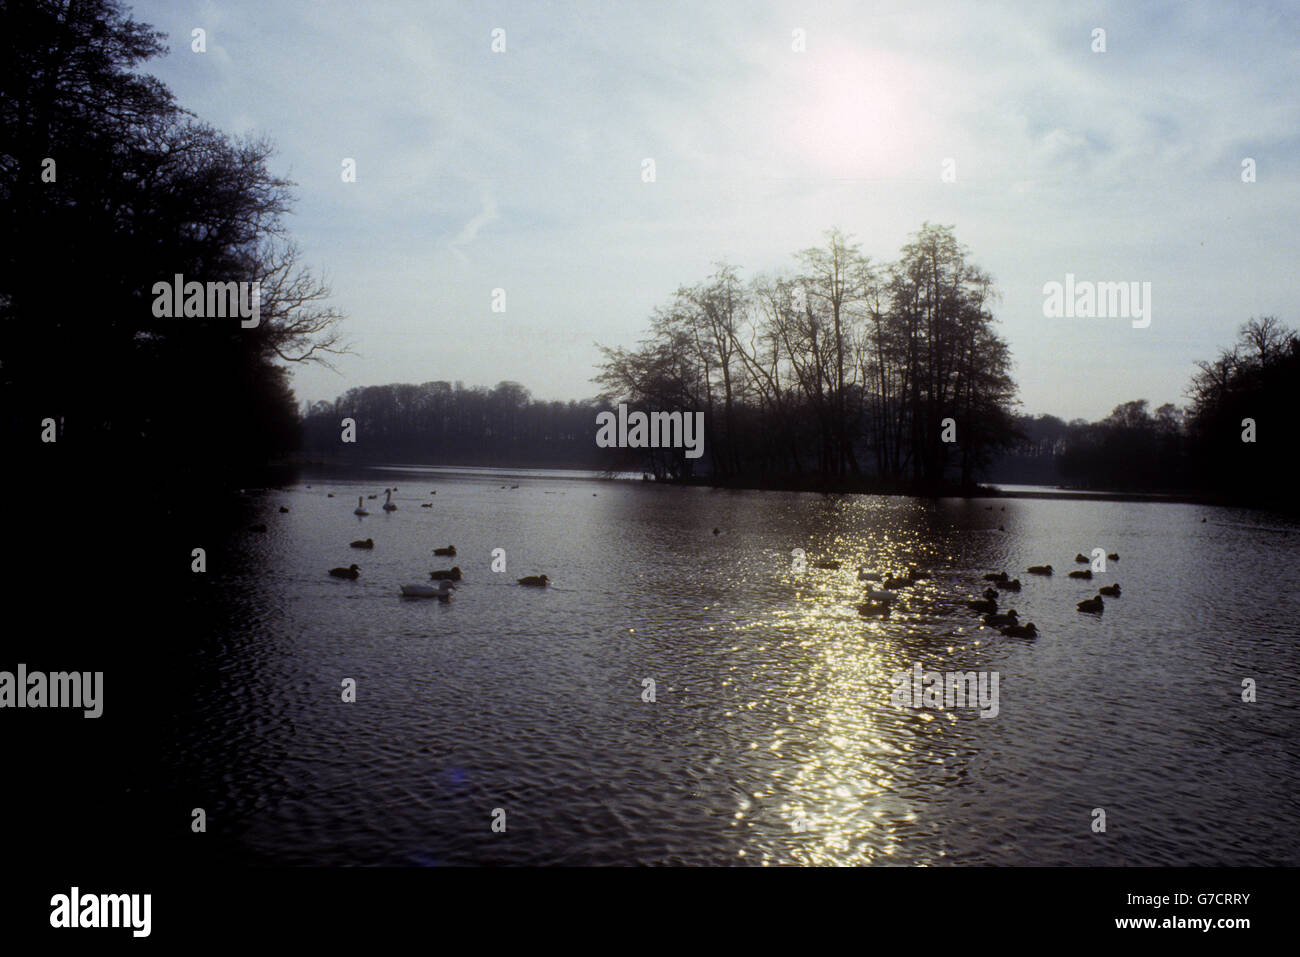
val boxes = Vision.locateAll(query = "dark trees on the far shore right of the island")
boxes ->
[992,316,1300,508]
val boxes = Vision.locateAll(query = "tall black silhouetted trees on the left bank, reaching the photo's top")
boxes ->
[0,0,342,486]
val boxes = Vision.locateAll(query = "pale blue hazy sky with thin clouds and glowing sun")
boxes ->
[129,0,1300,419]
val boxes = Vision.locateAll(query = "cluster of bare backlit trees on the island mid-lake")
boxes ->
[597,224,1015,488]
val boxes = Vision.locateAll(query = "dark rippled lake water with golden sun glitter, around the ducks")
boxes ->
[163,471,1300,865]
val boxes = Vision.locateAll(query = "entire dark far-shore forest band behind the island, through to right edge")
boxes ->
[293,317,1300,511]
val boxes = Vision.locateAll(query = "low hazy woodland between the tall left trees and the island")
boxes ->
[302,382,624,469]
